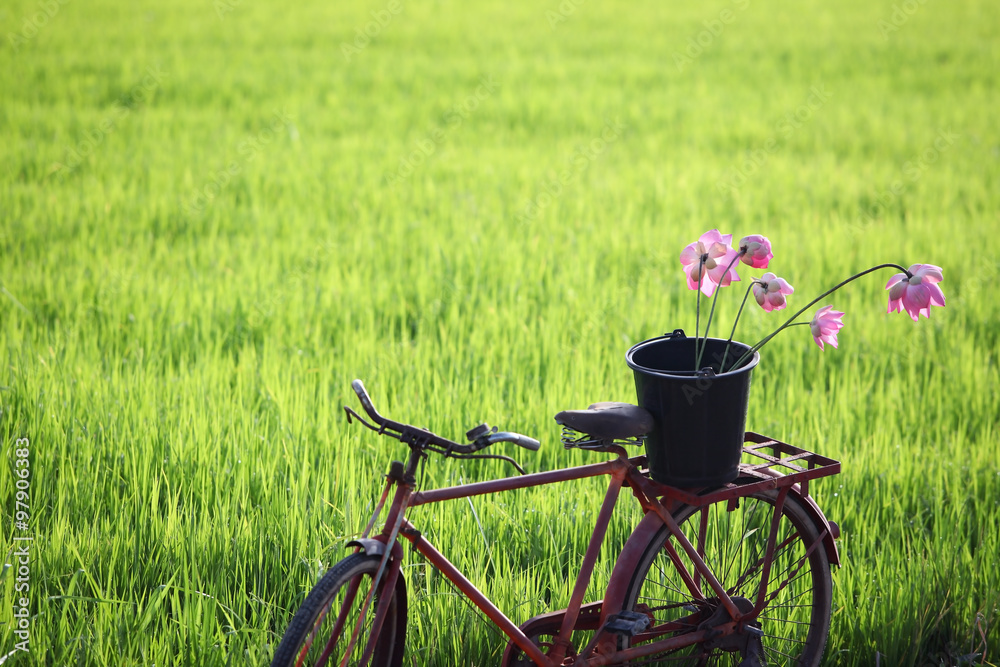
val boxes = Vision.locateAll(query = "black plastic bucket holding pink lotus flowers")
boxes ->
[625,329,760,487]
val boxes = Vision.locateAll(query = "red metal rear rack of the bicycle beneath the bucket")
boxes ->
[650,431,840,507]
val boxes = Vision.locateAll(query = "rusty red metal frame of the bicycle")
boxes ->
[345,433,840,667]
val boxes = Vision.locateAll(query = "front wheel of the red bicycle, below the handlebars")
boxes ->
[271,553,406,667]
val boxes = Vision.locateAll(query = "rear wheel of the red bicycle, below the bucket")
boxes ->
[622,491,833,667]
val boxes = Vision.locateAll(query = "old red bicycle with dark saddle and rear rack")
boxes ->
[272,380,840,667]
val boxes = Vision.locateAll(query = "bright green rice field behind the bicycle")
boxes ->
[0,0,1000,667]
